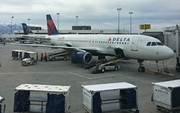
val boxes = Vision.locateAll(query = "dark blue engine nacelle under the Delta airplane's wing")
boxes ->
[72,51,92,64]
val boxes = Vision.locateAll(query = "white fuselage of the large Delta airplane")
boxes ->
[47,35,174,60]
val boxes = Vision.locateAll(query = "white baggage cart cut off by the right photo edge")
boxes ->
[152,79,180,113]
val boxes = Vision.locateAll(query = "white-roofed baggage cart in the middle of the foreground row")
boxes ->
[82,82,139,113]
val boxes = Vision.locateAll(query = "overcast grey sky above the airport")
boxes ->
[0,0,180,33]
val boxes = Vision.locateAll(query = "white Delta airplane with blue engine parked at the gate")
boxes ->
[14,14,174,72]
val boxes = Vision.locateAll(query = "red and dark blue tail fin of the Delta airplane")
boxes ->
[46,14,59,35]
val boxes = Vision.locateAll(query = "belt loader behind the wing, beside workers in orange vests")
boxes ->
[48,51,69,61]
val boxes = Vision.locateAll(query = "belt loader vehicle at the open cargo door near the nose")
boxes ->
[90,59,121,74]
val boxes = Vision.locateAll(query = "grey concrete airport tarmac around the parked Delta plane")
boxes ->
[0,44,180,113]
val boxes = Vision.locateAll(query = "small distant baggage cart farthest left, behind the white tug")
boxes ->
[12,50,27,60]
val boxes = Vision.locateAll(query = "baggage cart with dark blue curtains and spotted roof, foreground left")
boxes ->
[14,84,71,113]
